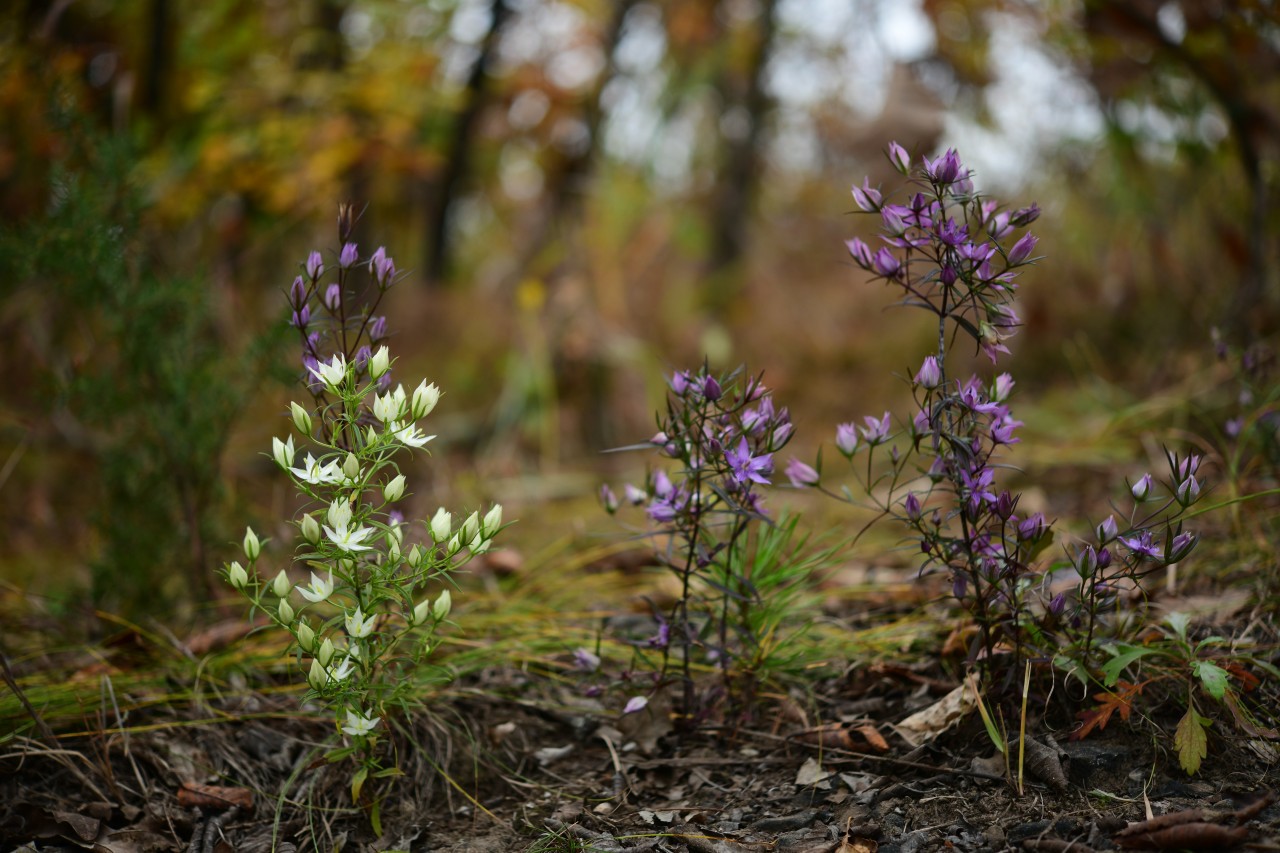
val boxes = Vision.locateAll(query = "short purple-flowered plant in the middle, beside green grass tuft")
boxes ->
[600,365,808,727]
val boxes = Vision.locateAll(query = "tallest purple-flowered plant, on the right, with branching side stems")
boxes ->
[787,143,1202,684]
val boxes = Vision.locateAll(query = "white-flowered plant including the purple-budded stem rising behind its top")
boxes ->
[223,211,502,822]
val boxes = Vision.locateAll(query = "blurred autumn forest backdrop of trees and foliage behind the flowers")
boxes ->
[0,0,1280,613]
